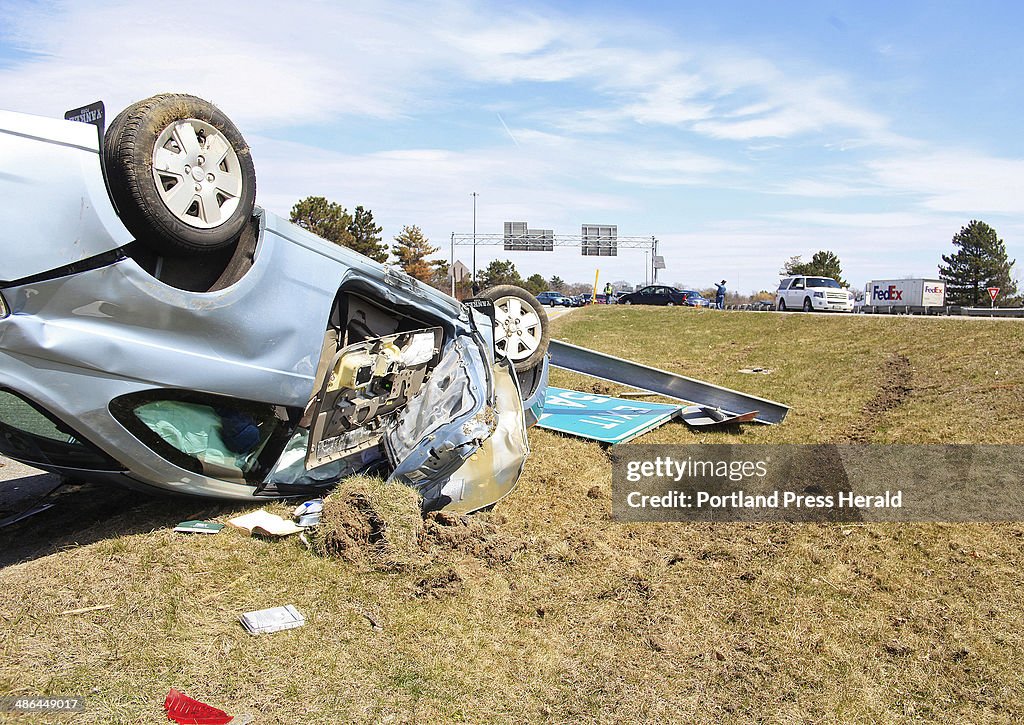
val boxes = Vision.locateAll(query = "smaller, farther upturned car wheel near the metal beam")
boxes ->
[482,285,554,373]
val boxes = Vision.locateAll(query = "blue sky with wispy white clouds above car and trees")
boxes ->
[0,0,1024,292]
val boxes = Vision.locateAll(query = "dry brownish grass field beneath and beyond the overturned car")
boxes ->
[0,307,1024,723]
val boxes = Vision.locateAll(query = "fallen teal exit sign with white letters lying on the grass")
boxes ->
[538,387,683,443]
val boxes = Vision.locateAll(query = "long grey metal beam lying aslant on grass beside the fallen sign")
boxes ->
[548,340,790,424]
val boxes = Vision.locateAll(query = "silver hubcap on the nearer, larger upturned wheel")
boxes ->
[153,119,242,229]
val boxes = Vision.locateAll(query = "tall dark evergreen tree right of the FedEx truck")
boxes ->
[939,219,1017,306]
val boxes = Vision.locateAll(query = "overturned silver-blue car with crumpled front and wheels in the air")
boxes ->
[0,94,549,511]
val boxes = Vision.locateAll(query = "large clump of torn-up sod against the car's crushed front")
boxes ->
[310,476,424,570]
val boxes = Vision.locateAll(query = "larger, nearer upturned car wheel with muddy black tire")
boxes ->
[103,93,256,255]
